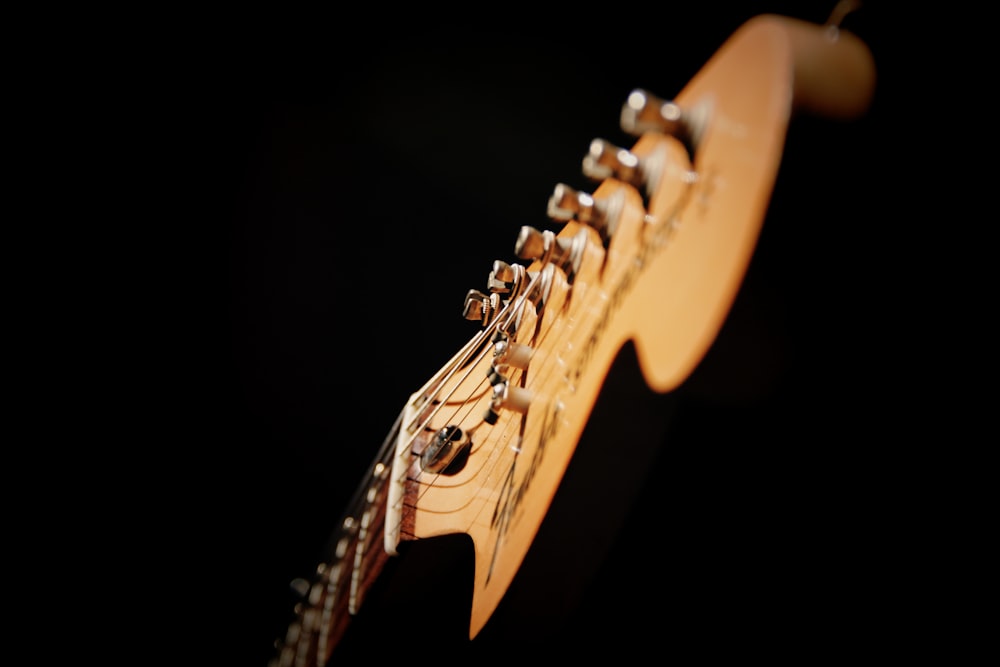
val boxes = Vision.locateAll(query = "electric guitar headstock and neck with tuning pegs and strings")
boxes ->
[273,9,875,666]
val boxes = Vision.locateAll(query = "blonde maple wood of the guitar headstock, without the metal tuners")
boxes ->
[390,16,875,637]
